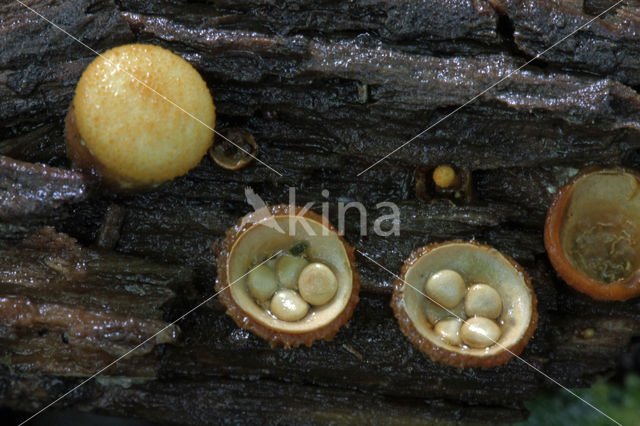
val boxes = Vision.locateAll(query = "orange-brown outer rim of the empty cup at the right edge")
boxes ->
[544,167,640,300]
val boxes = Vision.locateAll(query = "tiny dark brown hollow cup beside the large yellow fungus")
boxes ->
[209,127,258,170]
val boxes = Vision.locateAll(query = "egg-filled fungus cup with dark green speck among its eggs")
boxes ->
[216,205,360,347]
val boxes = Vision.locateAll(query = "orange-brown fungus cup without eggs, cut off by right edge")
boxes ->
[544,168,640,300]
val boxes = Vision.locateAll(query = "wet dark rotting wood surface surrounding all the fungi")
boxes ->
[0,0,640,425]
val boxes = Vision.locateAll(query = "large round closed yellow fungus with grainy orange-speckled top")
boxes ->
[73,44,215,184]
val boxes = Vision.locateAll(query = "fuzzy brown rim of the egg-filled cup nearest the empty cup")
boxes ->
[391,240,538,368]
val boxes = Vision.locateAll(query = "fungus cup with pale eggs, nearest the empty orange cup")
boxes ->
[391,241,538,367]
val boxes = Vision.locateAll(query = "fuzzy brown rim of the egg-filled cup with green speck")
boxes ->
[215,204,360,348]
